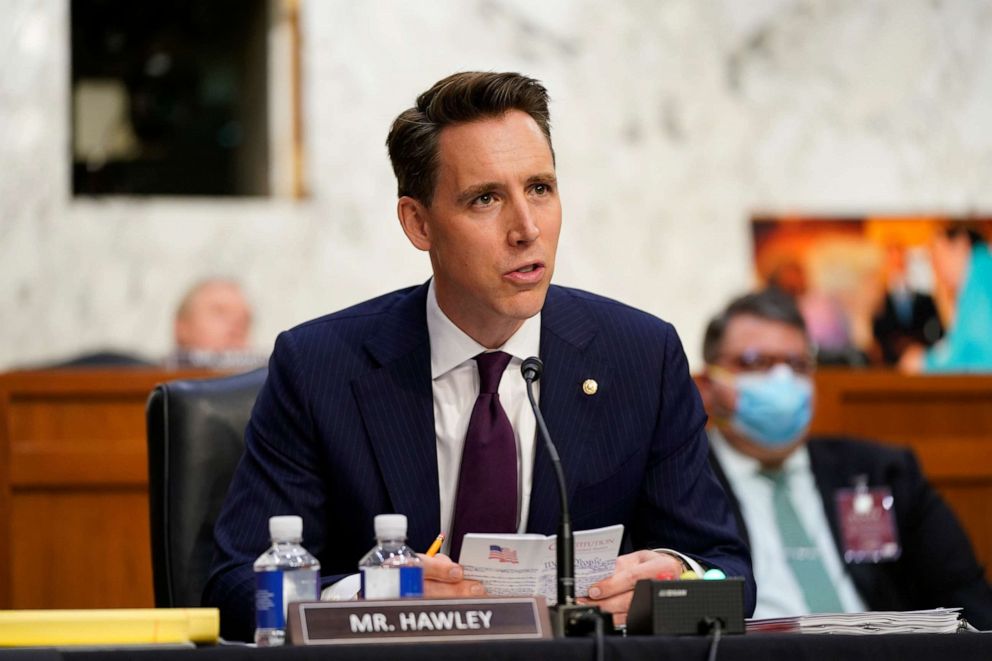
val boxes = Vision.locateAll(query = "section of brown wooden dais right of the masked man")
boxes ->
[812,369,992,580]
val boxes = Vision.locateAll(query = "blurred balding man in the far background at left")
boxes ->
[166,278,260,369]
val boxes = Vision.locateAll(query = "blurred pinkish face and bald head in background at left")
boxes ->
[175,281,251,352]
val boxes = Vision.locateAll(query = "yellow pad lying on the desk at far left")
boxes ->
[0,608,220,647]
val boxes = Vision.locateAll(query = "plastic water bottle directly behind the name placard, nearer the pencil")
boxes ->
[358,514,424,599]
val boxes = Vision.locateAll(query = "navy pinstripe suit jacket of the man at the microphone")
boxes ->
[204,284,754,639]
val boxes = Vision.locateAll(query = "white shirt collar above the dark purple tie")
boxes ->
[427,278,541,379]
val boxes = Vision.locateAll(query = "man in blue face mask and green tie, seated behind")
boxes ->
[698,290,992,629]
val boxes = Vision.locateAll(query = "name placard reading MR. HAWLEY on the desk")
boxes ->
[287,597,551,645]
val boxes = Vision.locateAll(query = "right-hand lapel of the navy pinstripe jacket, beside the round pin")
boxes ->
[527,287,611,534]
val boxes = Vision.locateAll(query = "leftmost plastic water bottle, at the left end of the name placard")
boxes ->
[254,516,320,647]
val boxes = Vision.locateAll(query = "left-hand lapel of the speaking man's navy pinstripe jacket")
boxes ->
[352,284,440,548]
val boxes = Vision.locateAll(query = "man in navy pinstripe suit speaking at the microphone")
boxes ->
[204,73,754,638]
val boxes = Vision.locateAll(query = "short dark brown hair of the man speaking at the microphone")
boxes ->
[386,71,554,207]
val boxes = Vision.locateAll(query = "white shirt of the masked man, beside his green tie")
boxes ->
[707,428,865,618]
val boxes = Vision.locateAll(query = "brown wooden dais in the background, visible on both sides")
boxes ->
[0,369,992,609]
